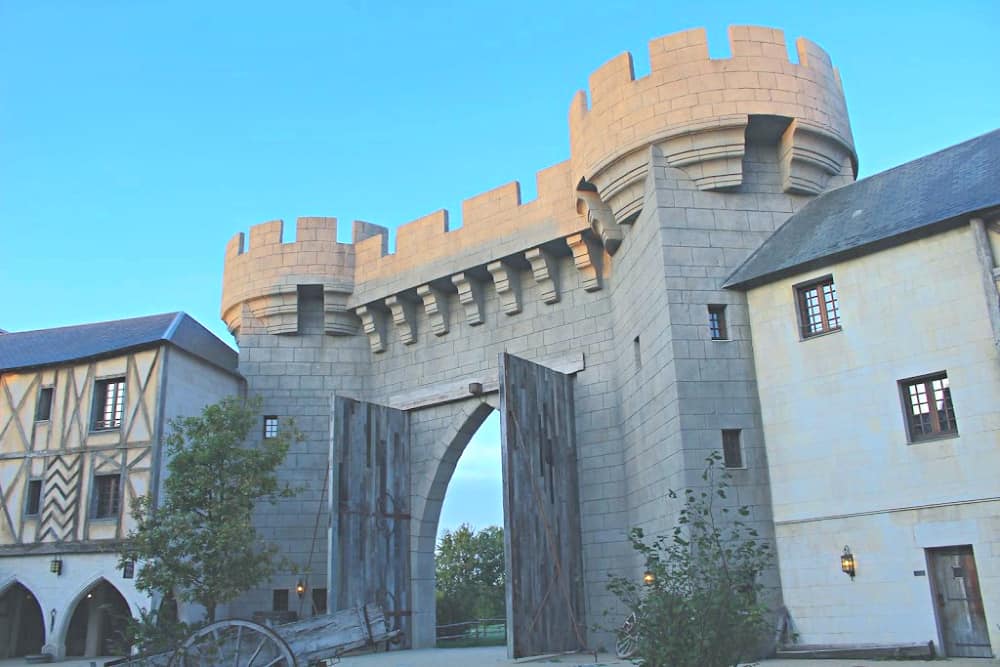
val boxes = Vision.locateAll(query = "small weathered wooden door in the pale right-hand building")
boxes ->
[927,545,993,658]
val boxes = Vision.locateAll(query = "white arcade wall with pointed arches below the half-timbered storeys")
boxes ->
[0,553,151,657]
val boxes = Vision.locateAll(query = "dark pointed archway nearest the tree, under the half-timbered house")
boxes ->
[66,579,131,657]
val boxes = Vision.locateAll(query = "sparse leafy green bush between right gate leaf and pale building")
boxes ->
[608,452,773,667]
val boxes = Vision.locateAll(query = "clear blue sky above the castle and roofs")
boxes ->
[0,0,1000,525]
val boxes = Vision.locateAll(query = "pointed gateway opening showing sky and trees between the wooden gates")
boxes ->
[434,410,506,648]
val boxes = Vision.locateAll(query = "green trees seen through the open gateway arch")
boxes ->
[435,523,505,625]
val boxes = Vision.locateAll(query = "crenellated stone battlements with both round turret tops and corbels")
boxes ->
[222,26,855,349]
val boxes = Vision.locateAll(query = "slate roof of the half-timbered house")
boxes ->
[0,312,238,373]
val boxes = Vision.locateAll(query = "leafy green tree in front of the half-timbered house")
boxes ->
[120,397,302,622]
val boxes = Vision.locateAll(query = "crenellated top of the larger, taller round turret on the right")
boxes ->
[569,26,856,221]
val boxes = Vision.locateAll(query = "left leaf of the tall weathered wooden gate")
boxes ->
[328,396,410,646]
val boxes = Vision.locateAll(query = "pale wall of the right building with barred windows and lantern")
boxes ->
[748,227,1000,650]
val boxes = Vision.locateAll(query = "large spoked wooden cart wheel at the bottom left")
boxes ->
[170,618,296,667]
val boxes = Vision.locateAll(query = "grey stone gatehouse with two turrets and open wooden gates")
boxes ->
[222,27,855,657]
